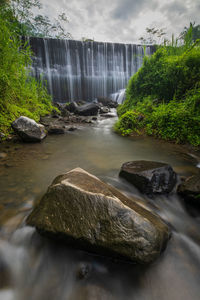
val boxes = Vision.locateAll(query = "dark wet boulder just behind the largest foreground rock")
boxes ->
[119,160,176,194]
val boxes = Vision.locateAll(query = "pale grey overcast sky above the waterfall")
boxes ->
[40,0,200,43]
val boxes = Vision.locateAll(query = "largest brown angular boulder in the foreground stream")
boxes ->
[26,168,169,263]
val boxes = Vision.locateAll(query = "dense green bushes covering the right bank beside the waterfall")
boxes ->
[115,33,200,146]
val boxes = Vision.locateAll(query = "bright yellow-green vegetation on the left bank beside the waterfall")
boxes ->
[0,1,63,136]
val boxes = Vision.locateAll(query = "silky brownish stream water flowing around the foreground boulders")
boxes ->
[0,113,200,300]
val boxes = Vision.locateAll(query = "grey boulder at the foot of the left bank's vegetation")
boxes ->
[12,116,46,142]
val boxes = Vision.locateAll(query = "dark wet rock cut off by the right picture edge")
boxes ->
[177,174,200,208]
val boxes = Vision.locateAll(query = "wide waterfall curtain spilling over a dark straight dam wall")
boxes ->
[29,38,154,102]
